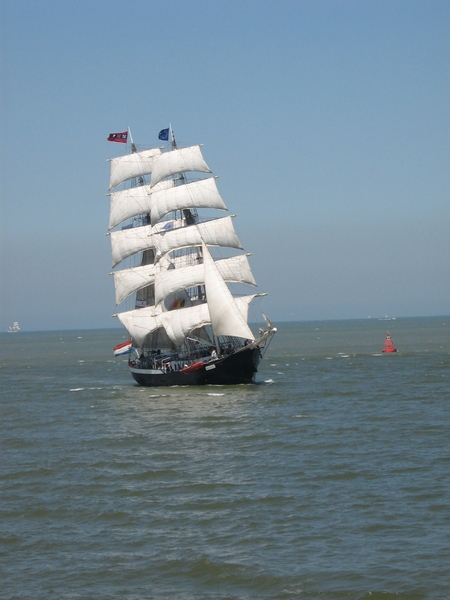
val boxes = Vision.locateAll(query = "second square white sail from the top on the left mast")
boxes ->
[108,179,173,229]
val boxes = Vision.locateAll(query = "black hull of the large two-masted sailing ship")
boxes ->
[131,347,262,387]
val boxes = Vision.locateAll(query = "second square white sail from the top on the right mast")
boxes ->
[150,177,227,224]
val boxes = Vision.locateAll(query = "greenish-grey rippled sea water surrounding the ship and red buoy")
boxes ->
[0,317,450,600]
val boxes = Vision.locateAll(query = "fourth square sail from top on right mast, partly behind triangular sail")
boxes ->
[154,254,256,304]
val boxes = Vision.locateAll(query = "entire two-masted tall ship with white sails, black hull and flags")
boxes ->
[108,126,276,386]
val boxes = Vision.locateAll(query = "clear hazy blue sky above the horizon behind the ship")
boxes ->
[0,0,450,331]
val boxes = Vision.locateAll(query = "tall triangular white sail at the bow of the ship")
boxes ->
[202,242,253,339]
